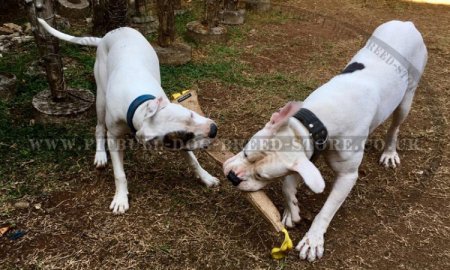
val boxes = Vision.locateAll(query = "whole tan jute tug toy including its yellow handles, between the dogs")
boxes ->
[172,90,293,259]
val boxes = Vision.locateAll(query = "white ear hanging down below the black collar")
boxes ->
[292,157,325,193]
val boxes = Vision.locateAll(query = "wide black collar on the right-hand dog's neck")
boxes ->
[292,108,328,161]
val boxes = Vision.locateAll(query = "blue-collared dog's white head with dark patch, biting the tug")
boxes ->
[136,97,217,150]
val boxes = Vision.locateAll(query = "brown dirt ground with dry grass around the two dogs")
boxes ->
[0,0,450,269]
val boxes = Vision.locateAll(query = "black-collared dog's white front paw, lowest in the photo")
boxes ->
[295,232,324,262]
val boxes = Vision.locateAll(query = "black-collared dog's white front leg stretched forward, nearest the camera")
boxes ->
[295,170,358,262]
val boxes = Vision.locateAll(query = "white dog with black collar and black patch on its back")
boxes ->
[224,21,427,261]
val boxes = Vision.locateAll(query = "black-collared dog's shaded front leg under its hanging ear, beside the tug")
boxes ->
[281,174,301,228]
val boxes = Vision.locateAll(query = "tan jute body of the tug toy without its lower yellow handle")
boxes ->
[172,91,284,232]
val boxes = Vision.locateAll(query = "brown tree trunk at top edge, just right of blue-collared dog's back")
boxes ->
[157,0,175,47]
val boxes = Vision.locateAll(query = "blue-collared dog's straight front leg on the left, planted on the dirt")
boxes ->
[108,131,129,214]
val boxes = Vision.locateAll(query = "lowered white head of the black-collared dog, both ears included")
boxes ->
[223,102,325,193]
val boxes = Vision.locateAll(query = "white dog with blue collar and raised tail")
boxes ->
[39,19,219,213]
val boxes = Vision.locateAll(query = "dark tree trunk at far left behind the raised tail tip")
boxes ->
[25,0,67,100]
